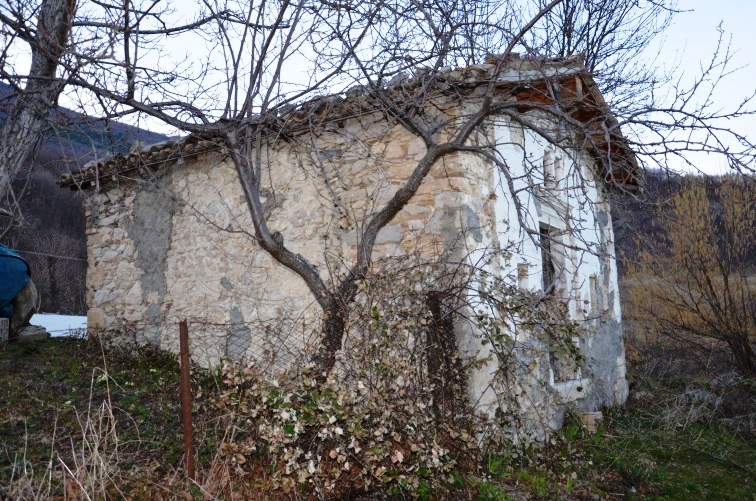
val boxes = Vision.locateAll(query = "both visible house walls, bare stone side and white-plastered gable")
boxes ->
[82,109,627,430]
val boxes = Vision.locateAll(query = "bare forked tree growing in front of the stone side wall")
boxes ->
[50,0,572,373]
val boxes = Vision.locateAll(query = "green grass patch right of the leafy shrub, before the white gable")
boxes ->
[469,378,756,501]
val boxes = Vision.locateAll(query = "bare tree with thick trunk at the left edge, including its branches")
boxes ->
[0,0,255,236]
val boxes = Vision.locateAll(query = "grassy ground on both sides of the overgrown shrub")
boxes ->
[0,338,756,500]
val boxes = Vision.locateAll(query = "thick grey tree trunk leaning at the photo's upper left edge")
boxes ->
[0,0,75,217]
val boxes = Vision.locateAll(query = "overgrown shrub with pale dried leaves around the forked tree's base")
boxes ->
[202,260,580,499]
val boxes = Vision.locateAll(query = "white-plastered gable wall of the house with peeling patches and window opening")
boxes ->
[494,118,628,410]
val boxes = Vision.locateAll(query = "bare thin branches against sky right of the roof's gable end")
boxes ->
[527,0,756,173]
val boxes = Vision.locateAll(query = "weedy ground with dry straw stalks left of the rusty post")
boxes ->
[0,339,180,499]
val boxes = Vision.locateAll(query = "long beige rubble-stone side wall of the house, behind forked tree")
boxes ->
[88,110,490,365]
